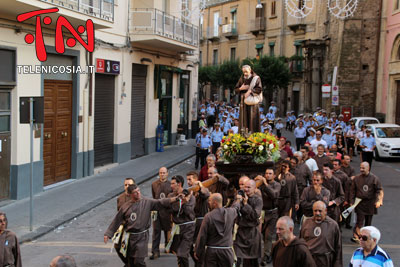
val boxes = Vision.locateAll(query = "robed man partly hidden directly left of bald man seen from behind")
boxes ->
[186,171,210,267]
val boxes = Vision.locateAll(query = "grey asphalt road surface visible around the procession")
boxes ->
[21,154,400,267]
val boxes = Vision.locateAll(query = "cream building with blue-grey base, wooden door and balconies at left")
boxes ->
[0,0,198,199]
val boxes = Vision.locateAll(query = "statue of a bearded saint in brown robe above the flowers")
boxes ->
[235,65,262,133]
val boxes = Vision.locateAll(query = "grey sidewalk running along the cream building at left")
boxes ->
[0,140,195,243]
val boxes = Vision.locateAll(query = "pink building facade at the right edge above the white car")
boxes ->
[376,0,400,124]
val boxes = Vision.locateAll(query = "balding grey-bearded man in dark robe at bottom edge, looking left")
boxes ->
[272,216,317,267]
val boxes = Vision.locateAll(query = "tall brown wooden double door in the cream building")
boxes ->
[43,80,72,185]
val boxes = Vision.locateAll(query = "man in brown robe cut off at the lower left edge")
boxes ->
[0,212,22,267]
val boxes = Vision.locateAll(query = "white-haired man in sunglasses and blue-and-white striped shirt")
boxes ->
[349,226,394,267]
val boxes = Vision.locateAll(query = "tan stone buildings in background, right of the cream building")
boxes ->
[200,0,381,119]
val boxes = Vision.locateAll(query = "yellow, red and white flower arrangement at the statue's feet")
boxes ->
[221,132,280,164]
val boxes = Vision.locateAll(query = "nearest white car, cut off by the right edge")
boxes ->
[367,123,400,160]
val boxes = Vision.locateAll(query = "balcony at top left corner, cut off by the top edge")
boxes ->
[0,0,114,29]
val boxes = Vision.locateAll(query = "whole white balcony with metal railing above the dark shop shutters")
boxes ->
[130,8,199,52]
